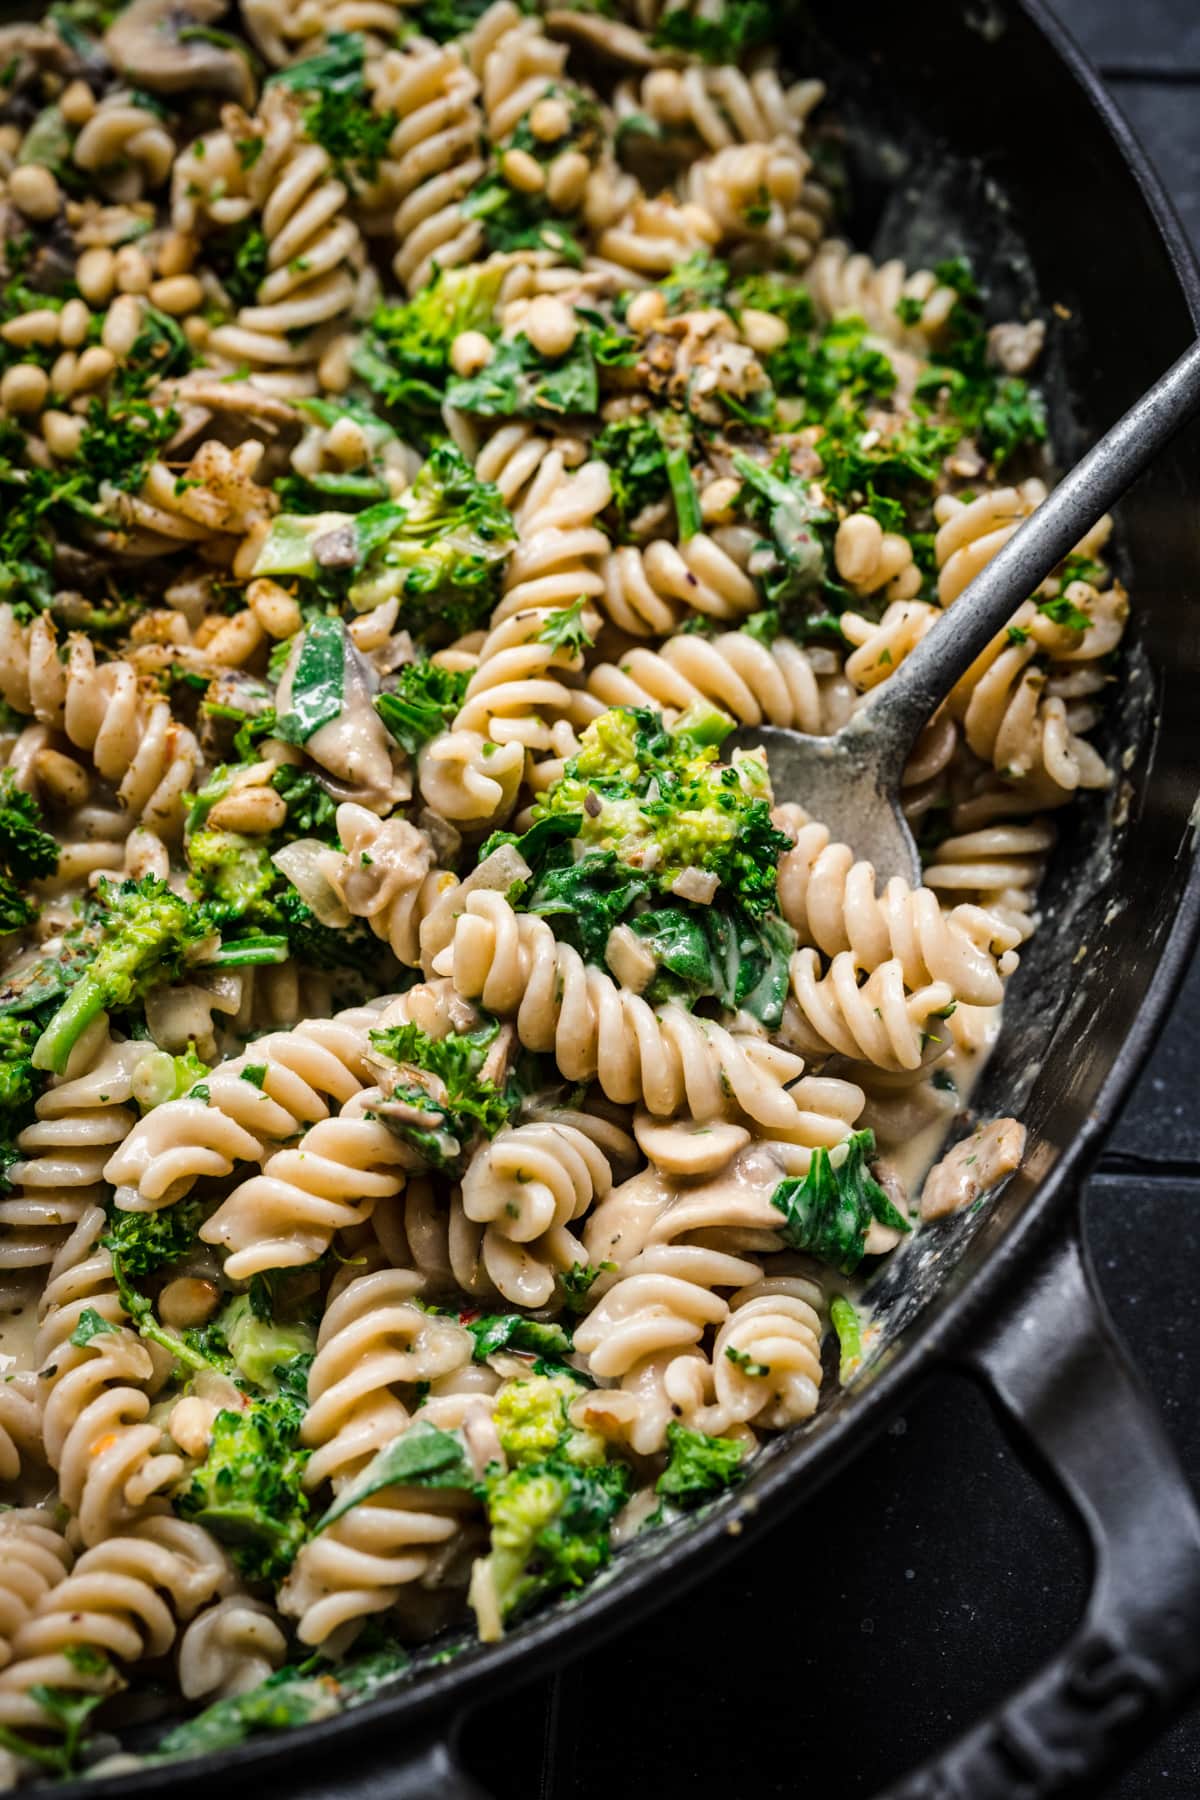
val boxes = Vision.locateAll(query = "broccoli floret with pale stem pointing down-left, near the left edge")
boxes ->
[34,875,212,1075]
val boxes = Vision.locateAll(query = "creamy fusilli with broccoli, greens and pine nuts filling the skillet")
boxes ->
[0,0,1128,1784]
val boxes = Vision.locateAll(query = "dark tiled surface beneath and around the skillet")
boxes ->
[455,0,1200,1800]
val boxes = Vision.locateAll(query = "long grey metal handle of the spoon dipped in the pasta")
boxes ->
[858,340,1200,767]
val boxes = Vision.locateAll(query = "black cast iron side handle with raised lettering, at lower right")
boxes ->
[880,1235,1200,1800]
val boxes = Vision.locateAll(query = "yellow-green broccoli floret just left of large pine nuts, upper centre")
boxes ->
[351,263,504,437]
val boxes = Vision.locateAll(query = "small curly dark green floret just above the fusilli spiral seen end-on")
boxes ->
[371,1019,520,1168]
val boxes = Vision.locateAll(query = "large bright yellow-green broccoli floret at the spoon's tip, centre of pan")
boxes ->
[534,707,788,918]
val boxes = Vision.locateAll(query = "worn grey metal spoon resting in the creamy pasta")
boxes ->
[727,342,1200,886]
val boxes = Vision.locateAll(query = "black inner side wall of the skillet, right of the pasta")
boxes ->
[793,0,1200,1353]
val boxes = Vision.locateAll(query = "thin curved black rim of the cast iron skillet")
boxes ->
[52,0,1200,1800]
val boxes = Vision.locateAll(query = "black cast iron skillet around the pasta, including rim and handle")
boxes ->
[37,0,1200,1800]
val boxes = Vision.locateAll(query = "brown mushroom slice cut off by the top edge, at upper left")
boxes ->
[104,0,254,106]
